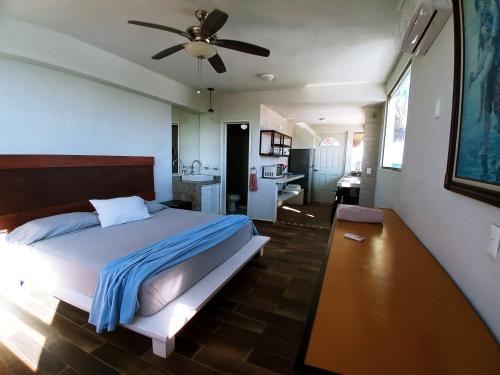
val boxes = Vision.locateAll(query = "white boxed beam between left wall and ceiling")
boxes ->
[0,15,207,110]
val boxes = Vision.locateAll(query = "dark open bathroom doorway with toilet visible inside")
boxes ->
[224,122,250,215]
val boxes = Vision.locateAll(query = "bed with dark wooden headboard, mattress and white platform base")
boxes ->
[0,155,269,357]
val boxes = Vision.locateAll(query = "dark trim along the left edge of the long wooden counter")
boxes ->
[294,216,338,375]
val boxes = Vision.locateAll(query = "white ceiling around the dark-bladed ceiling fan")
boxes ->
[0,0,398,93]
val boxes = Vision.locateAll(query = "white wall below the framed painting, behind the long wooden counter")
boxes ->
[375,20,500,340]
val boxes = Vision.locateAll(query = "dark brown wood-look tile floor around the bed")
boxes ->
[0,206,330,375]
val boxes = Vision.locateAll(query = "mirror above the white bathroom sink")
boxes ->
[172,107,201,174]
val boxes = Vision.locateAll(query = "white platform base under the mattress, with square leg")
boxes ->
[18,236,270,358]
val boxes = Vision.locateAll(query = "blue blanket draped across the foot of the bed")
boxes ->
[89,215,256,333]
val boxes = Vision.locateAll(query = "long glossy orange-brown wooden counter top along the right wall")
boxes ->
[298,210,500,375]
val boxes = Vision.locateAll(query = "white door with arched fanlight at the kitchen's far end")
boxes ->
[313,134,347,203]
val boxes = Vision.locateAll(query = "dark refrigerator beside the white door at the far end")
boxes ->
[288,148,316,204]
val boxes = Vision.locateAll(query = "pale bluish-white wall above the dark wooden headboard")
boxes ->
[0,58,172,200]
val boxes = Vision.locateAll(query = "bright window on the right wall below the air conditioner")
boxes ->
[382,68,411,170]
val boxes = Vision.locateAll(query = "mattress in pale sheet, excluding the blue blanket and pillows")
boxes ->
[1,208,252,315]
